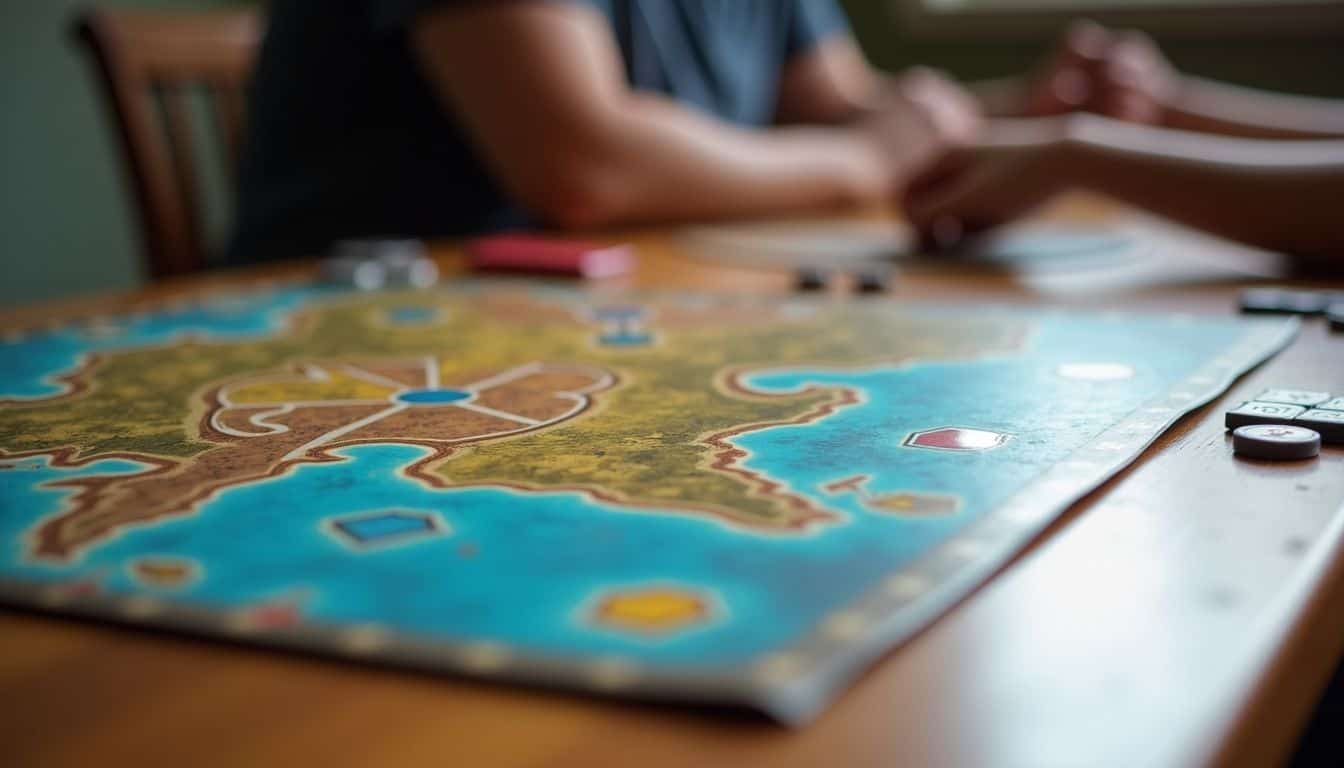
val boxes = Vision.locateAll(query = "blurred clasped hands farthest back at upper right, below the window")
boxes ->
[1025,22,1180,124]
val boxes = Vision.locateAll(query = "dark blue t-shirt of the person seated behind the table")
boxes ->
[228,0,845,262]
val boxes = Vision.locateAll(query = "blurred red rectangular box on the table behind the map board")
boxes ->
[466,234,634,278]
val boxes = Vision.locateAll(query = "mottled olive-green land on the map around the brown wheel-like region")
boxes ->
[0,291,1024,526]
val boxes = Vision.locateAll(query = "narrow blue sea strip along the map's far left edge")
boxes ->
[0,285,332,401]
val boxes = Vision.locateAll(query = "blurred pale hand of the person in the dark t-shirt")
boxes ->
[862,67,984,189]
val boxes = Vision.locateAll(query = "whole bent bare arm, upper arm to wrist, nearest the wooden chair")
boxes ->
[413,3,894,227]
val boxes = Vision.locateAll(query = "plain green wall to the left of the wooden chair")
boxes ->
[0,0,231,307]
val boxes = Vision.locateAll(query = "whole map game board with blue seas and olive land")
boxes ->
[0,281,1296,722]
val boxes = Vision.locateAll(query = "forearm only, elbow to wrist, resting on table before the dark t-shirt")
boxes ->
[534,94,894,226]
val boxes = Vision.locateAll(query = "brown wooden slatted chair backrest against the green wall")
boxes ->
[74,9,261,277]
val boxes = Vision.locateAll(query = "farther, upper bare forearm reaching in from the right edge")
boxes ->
[1163,75,1344,139]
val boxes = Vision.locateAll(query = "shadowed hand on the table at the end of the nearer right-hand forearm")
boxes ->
[905,117,1070,250]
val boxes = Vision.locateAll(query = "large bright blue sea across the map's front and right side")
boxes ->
[0,315,1250,667]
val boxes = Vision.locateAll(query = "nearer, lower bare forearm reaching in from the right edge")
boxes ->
[1062,118,1344,256]
